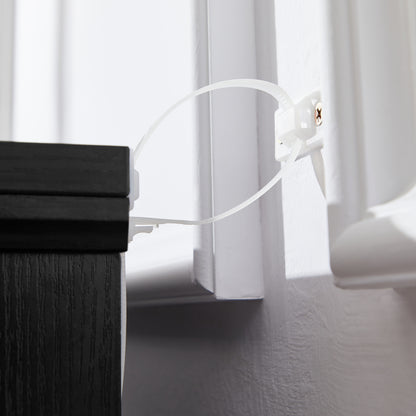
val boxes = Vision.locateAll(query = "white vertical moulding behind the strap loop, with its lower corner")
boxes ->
[127,0,264,306]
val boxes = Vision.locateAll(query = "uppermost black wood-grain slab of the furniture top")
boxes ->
[0,142,130,197]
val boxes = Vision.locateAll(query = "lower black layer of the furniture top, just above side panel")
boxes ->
[0,195,129,252]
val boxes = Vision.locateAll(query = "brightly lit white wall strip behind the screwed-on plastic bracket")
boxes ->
[275,1,331,279]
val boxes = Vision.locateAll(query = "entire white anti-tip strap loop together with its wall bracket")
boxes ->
[129,79,325,241]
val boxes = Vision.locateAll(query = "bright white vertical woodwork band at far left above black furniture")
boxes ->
[12,0,63,143]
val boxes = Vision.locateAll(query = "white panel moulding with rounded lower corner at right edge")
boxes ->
[322,0,416,288]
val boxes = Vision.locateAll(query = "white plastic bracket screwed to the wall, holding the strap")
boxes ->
[275,91,325,195]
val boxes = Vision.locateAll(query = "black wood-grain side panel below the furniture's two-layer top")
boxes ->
[0,253,121,416]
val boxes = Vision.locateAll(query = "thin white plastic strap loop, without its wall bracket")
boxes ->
[130,79,304,237]
